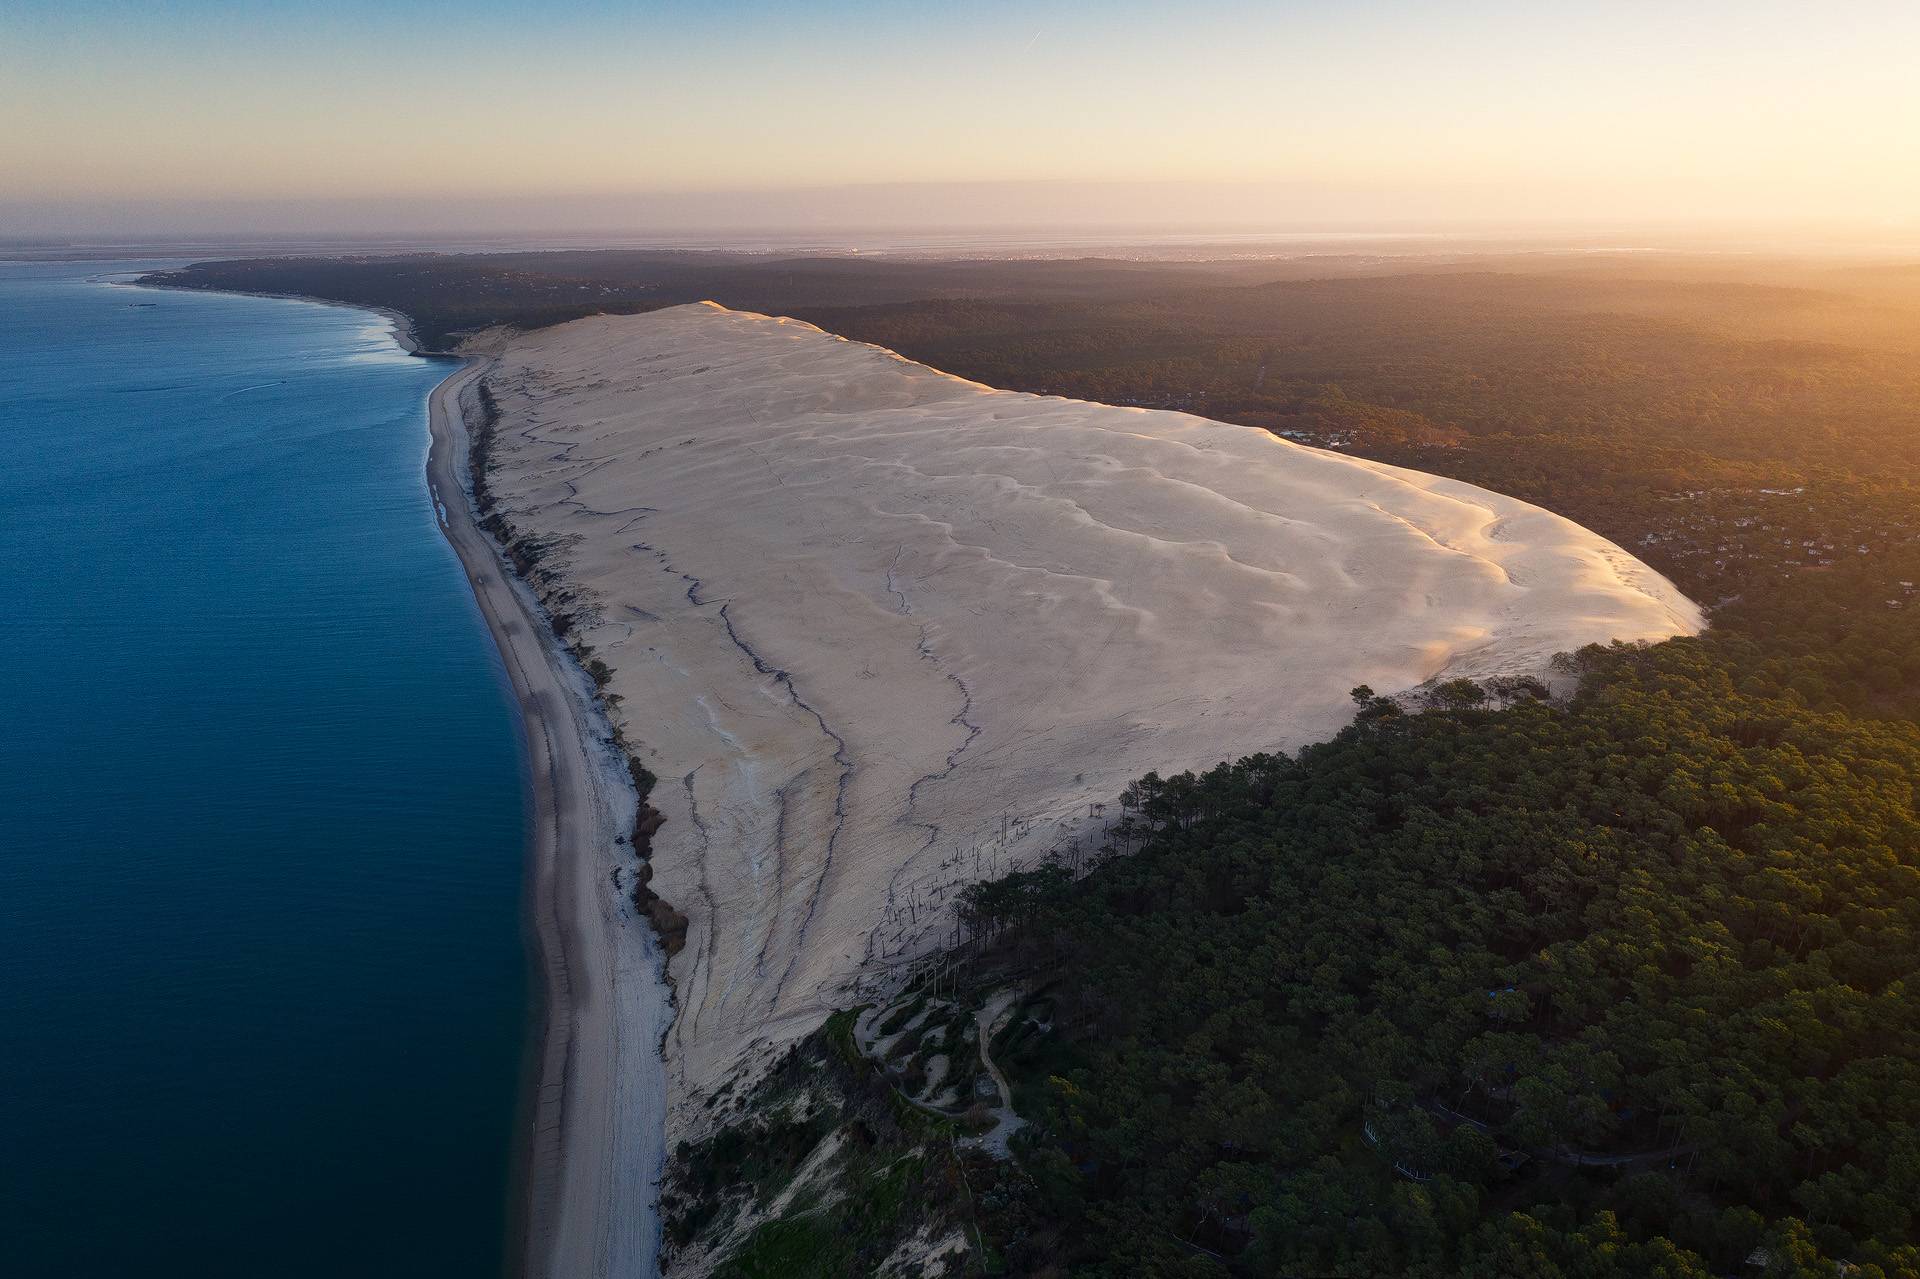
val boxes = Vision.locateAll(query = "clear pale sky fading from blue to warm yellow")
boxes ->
[0,0,1920,236]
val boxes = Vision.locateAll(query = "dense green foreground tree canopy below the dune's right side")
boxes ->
[970,595,1920,1275]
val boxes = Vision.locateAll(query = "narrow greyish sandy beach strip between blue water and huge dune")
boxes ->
[426,361,670,1279]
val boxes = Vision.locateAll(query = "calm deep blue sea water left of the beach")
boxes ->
[0,263,528,1279]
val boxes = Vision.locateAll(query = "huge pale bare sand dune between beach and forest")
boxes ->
[472,305,1701,1135]
